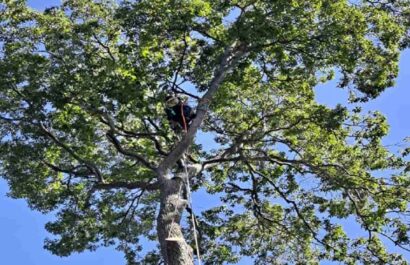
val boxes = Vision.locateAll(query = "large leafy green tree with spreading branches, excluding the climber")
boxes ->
[0,0,410,265]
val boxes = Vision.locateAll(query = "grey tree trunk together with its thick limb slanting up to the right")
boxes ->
[155,42,246,265]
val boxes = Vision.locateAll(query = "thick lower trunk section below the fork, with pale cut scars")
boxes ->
[157,177,194,265]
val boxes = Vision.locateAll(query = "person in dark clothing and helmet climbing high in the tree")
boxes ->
[165,96,196,132]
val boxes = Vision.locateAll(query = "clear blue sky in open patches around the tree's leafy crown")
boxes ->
[0,0,410,265]
